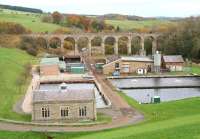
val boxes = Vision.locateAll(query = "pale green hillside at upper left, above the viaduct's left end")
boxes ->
[0,9,61,32]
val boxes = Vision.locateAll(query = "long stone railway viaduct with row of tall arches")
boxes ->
[23,33,161,55]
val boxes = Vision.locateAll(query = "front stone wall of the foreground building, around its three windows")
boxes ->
[32,100,96,122]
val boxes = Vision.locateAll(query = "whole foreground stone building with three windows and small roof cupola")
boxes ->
[32,83,96,122]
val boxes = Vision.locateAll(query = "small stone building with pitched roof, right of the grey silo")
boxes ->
[162,55,184,71]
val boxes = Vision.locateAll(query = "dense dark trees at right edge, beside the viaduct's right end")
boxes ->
[158,17,200,62]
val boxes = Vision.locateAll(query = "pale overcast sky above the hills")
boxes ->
[0,0,200,17]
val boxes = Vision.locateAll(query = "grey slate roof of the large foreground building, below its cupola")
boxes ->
[33,89,95,103]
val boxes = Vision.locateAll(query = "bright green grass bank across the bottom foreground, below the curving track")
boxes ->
[0,90,200,139]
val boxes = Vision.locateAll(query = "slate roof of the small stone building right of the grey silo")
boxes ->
[163,55,184,63]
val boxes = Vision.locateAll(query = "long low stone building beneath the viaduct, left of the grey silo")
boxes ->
[103,56,153,74]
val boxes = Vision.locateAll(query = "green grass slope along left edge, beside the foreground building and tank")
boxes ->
[0,48,33,120]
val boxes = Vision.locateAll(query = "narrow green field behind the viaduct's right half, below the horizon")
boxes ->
[106,20,174,30]
